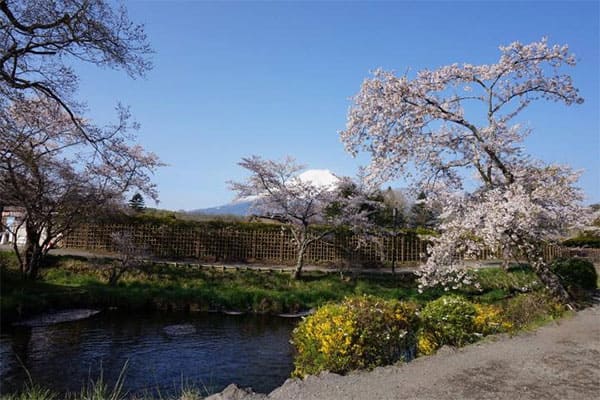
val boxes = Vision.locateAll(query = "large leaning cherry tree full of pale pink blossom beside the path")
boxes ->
[340,38,585,301]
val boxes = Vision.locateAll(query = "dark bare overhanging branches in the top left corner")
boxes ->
[0,0,152,219]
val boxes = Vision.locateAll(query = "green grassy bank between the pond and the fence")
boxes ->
[0,252,539,321]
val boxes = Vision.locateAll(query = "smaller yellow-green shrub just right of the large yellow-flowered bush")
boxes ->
[418,295,477,354]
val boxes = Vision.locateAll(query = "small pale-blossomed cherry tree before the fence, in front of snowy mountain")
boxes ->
[229,156,371,279]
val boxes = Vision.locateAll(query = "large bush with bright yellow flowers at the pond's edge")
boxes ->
[292,296,417,377]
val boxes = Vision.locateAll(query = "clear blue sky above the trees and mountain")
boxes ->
[78,1,600,210]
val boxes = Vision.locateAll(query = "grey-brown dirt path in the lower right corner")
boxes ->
[212,305,600,400]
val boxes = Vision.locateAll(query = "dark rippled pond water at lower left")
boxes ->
[0,312,297,394]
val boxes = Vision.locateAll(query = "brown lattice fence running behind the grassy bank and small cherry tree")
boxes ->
[62,224,584,266]
